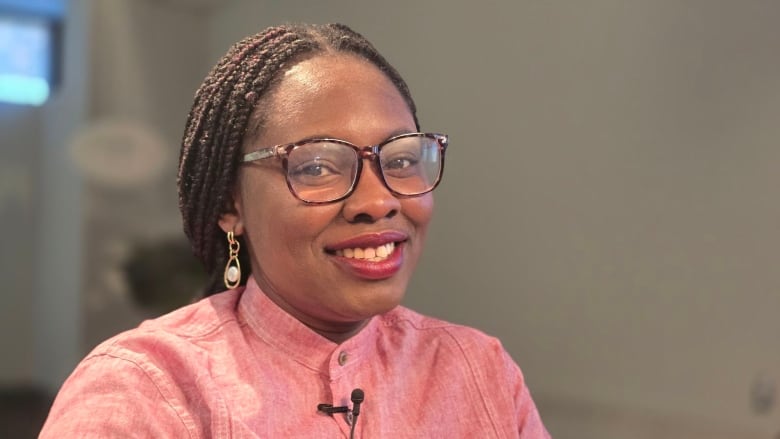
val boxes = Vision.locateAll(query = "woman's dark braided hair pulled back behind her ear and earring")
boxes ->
[177,24,419,296]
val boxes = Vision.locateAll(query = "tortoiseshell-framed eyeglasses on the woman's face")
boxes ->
[242,133,449,204]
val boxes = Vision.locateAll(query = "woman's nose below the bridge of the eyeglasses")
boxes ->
[343,160,401,223]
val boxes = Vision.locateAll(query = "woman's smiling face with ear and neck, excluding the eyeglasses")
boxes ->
[220,55,433,341]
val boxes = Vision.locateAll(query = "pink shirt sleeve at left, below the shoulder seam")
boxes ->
[39,354,198,439]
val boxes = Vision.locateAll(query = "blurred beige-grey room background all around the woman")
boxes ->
[0,0,780,439]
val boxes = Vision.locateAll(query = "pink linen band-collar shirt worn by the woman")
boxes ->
[40,279,550,439]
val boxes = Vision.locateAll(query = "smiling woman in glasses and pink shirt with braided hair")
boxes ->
[41,25,549,438]
